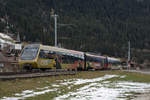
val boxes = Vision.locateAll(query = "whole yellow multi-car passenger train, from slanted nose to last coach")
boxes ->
[19,44,120,70]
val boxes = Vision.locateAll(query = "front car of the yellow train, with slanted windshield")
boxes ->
[19,44,84,70]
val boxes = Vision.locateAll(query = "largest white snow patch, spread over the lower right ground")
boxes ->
[55,81,150,100]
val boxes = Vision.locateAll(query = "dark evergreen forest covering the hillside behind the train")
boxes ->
[0,0,150,62]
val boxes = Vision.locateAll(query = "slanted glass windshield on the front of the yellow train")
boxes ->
[21,47,39,60]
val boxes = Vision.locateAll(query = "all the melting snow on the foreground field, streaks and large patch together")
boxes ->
[0,75,150,100]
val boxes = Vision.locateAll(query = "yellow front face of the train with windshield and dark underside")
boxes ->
[19,44,40,70]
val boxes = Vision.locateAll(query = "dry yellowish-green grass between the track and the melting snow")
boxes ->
[0,71,150,100]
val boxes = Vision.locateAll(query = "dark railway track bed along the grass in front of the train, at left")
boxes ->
[0,70,76,80]
